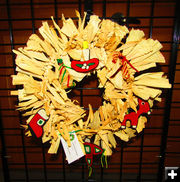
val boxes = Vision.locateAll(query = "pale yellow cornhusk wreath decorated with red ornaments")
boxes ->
[11,11,171,167]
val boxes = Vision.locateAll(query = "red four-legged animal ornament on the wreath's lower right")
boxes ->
[121,99,150,128]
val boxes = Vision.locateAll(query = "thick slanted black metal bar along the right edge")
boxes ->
[157,0,180,182]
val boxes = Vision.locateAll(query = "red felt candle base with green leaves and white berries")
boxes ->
[71,58,99,73]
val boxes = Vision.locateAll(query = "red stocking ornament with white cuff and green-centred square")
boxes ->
[29,109,48,138]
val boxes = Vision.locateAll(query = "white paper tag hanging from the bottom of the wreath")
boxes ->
[61,133,84,164]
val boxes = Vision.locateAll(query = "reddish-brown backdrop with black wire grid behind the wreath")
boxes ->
[0,0,180,182]
